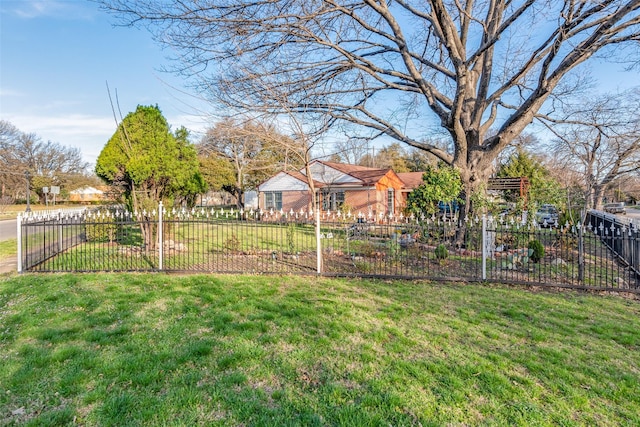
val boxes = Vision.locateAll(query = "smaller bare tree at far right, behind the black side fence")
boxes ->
[544,89,640,209]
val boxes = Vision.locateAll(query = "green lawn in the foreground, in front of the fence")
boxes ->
[0,274,640,426]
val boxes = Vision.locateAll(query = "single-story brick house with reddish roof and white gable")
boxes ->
[258,160,422,215]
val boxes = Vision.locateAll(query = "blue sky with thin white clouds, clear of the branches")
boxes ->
[0,0,638,169]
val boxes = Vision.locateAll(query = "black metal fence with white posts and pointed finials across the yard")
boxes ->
[19,207,640,292]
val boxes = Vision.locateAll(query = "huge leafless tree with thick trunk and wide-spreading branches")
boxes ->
[99,0,640,221]
